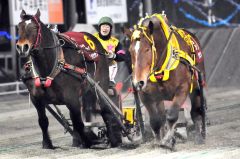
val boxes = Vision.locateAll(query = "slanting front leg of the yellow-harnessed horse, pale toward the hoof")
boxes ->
[161,85,188,150]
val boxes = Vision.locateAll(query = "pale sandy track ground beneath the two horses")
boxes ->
[0,88,240,159]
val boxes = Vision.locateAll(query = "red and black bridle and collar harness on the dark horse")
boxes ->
[20,13,87,87]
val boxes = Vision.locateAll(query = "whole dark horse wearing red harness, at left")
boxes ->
[16,10,121,149]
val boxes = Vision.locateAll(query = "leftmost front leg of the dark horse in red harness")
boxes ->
[31,97,54,149]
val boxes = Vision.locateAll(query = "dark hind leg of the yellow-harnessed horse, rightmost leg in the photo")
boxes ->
[191,89,205,144]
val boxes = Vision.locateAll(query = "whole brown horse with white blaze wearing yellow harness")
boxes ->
[125,14,205,149]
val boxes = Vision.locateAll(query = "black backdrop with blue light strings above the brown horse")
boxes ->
[127,0,240,28]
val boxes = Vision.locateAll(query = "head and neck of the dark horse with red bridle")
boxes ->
[16,9,61,77]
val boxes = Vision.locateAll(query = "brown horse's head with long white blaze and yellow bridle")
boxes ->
[124,18,166,90]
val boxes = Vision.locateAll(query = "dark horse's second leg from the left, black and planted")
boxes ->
[68,105,91,148]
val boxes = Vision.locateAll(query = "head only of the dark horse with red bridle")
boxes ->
[16,10,41,57]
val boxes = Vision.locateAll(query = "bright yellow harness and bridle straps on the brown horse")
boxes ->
[131,14,195,92]
